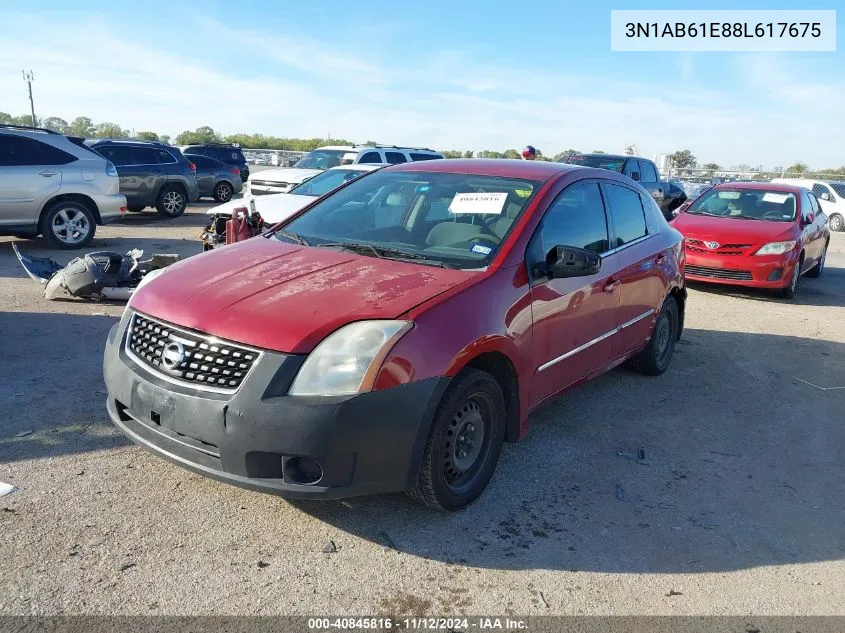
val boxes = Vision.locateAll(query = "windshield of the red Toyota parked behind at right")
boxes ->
[687,188,795,222]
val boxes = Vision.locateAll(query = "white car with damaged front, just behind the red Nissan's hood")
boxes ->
[206,163,382,224]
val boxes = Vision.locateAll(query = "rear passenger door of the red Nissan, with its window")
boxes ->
[602,181,669,357]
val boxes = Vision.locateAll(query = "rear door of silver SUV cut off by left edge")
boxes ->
[0,134,68,226]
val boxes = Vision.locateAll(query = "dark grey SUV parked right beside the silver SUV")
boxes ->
[85,139,199,218]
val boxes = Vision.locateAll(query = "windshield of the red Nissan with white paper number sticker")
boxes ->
[275,171,540,268]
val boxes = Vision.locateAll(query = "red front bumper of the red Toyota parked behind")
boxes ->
[685,249,798,288]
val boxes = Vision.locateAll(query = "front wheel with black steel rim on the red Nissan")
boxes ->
[408,369,506,511]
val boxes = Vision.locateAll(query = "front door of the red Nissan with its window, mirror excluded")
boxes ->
[526,180,619,405]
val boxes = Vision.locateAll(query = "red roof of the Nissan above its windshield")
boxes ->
[385,158,576,180]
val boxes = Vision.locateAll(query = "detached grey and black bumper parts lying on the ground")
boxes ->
[12,244,179,301]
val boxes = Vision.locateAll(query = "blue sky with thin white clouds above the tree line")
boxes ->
[0,0,845,169]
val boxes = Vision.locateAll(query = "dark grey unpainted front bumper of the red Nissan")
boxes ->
[103,311,448,499]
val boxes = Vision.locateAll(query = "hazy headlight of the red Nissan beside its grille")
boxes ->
[288,321,413,396]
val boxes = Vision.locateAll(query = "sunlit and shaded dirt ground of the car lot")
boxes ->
[0,207,845,615]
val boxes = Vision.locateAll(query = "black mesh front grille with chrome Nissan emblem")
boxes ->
[126,313,261,392]
